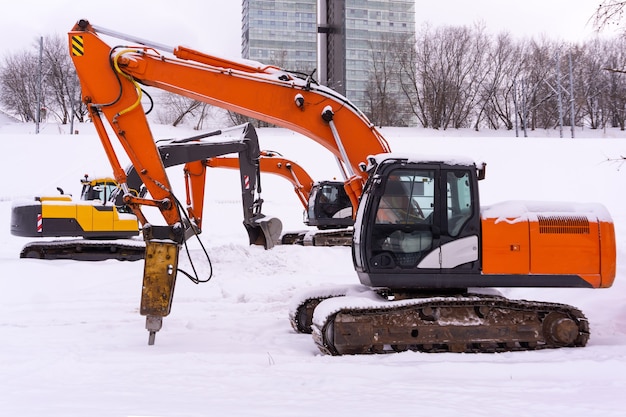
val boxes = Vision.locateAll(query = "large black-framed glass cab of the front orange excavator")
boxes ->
[353,158,480,289]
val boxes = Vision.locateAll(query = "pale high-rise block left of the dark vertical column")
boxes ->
[241,0,317,74]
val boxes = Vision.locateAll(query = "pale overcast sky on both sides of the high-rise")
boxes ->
[0,0,616,58]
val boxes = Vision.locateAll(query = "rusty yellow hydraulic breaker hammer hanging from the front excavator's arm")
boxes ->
[140,240,179,345]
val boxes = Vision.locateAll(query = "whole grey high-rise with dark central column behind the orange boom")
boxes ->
[242,0,415,123]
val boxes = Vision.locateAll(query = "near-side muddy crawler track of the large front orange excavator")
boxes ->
[312,295,589,355]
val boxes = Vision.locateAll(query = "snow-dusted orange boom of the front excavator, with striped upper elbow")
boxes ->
[69,20,390,211]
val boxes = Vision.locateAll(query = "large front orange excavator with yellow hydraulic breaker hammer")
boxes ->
[68,20,616,355]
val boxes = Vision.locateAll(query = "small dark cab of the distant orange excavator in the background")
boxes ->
[304,181,354,229]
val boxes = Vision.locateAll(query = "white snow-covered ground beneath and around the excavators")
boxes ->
[0,121,626,417]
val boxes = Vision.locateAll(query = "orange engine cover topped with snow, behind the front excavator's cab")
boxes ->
[481,202,616,288]
